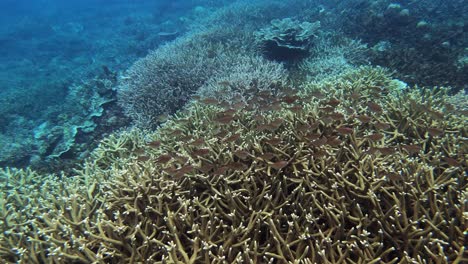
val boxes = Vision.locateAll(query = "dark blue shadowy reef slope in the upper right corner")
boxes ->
[329,0,468,91]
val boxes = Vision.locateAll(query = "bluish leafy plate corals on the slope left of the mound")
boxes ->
[0,68,125,172]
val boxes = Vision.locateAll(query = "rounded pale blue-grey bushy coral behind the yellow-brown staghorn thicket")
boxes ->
[118,32,250,128]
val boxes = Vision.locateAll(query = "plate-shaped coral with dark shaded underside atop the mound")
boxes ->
[255,18,320,61]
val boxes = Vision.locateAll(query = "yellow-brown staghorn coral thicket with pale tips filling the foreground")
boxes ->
[0,67,467,263]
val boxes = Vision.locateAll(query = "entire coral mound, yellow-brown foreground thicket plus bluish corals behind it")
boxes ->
[0,1,468,264]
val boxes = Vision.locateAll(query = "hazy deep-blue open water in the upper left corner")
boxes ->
[0,0,188,111]
